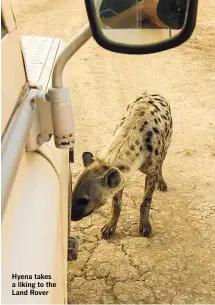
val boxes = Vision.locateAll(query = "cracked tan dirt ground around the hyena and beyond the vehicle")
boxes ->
[12,0,215,304]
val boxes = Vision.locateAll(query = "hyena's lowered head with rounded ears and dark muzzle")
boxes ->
[71,152,122,221]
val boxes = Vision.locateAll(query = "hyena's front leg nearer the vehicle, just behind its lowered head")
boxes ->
[101,189,123,239]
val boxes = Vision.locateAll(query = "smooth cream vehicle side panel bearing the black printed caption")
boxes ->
[1,152,65,304]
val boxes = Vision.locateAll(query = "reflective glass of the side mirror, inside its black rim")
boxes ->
[93,0,189,46]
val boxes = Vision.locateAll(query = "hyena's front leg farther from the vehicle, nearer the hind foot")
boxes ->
[139,174,158,237]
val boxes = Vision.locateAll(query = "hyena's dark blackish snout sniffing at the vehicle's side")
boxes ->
[71,197,93,221]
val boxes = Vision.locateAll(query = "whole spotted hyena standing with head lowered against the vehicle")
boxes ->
[71,92,172,238]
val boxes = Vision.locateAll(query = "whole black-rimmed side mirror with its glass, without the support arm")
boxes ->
[85,0,198,54]
